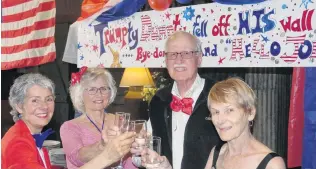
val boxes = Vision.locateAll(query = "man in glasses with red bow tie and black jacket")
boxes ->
[132,31,220,169]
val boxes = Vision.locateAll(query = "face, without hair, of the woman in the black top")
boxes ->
[210,101,254,141]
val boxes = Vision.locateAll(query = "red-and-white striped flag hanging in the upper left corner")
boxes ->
[1,0,56,70]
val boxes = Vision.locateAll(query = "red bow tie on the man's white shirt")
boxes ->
[170,95,193,115]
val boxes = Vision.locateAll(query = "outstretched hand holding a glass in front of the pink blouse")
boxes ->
[101,132,135,163]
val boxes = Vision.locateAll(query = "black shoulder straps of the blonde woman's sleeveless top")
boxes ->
[212,144,279,169]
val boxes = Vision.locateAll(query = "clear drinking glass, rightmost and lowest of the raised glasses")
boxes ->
[144,136,161,169]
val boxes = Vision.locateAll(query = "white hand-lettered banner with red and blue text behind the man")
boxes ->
[77,0,316,67]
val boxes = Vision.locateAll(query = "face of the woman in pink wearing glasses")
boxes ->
[83,77,111,111]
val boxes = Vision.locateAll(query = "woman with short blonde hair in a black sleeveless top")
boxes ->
[205,78,286,169]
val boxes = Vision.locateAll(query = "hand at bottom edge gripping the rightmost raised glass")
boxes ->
[141,148,172,169]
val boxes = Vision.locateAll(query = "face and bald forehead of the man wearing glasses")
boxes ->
[166,33,202,81]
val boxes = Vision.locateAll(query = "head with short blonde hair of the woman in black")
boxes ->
[207,77,256,141]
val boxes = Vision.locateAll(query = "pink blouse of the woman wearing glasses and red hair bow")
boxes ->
[60,121,137,169]
